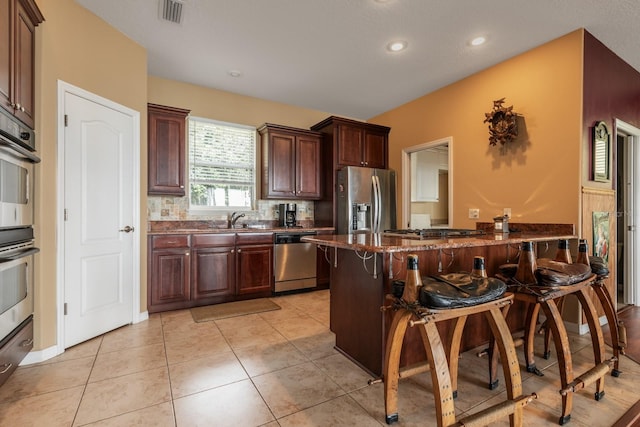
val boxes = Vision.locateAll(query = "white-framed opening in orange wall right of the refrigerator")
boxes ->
[401,137,453,229]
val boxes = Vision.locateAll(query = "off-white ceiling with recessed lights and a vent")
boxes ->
[76,0,640,120]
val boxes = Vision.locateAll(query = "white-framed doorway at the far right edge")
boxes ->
[615,120,640,311]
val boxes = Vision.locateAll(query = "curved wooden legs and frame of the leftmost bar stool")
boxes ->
[383,294,536,427]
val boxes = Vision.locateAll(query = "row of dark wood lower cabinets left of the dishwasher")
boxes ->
[147,233,273,313]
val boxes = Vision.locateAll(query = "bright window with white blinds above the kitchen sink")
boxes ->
[189,117,256,210]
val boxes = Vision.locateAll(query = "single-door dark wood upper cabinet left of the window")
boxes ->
[147,104,190,196]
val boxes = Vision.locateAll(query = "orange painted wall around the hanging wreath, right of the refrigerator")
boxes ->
[369,30,583,231]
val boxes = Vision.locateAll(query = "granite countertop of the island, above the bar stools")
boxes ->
[302,232,578,252]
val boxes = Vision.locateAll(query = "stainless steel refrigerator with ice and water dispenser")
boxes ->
[336,166,396,234]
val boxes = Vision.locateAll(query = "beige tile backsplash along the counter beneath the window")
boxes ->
[147,196,313,222]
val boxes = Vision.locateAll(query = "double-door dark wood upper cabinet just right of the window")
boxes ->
[258,124,322,200]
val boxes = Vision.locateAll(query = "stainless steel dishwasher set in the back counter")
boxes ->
[274,231,317,292]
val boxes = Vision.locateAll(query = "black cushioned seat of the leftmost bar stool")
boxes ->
[419,273,507,308]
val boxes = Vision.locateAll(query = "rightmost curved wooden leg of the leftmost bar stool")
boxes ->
[485,308,524,427]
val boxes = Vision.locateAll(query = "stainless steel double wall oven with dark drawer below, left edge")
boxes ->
[0,104,40,384]
